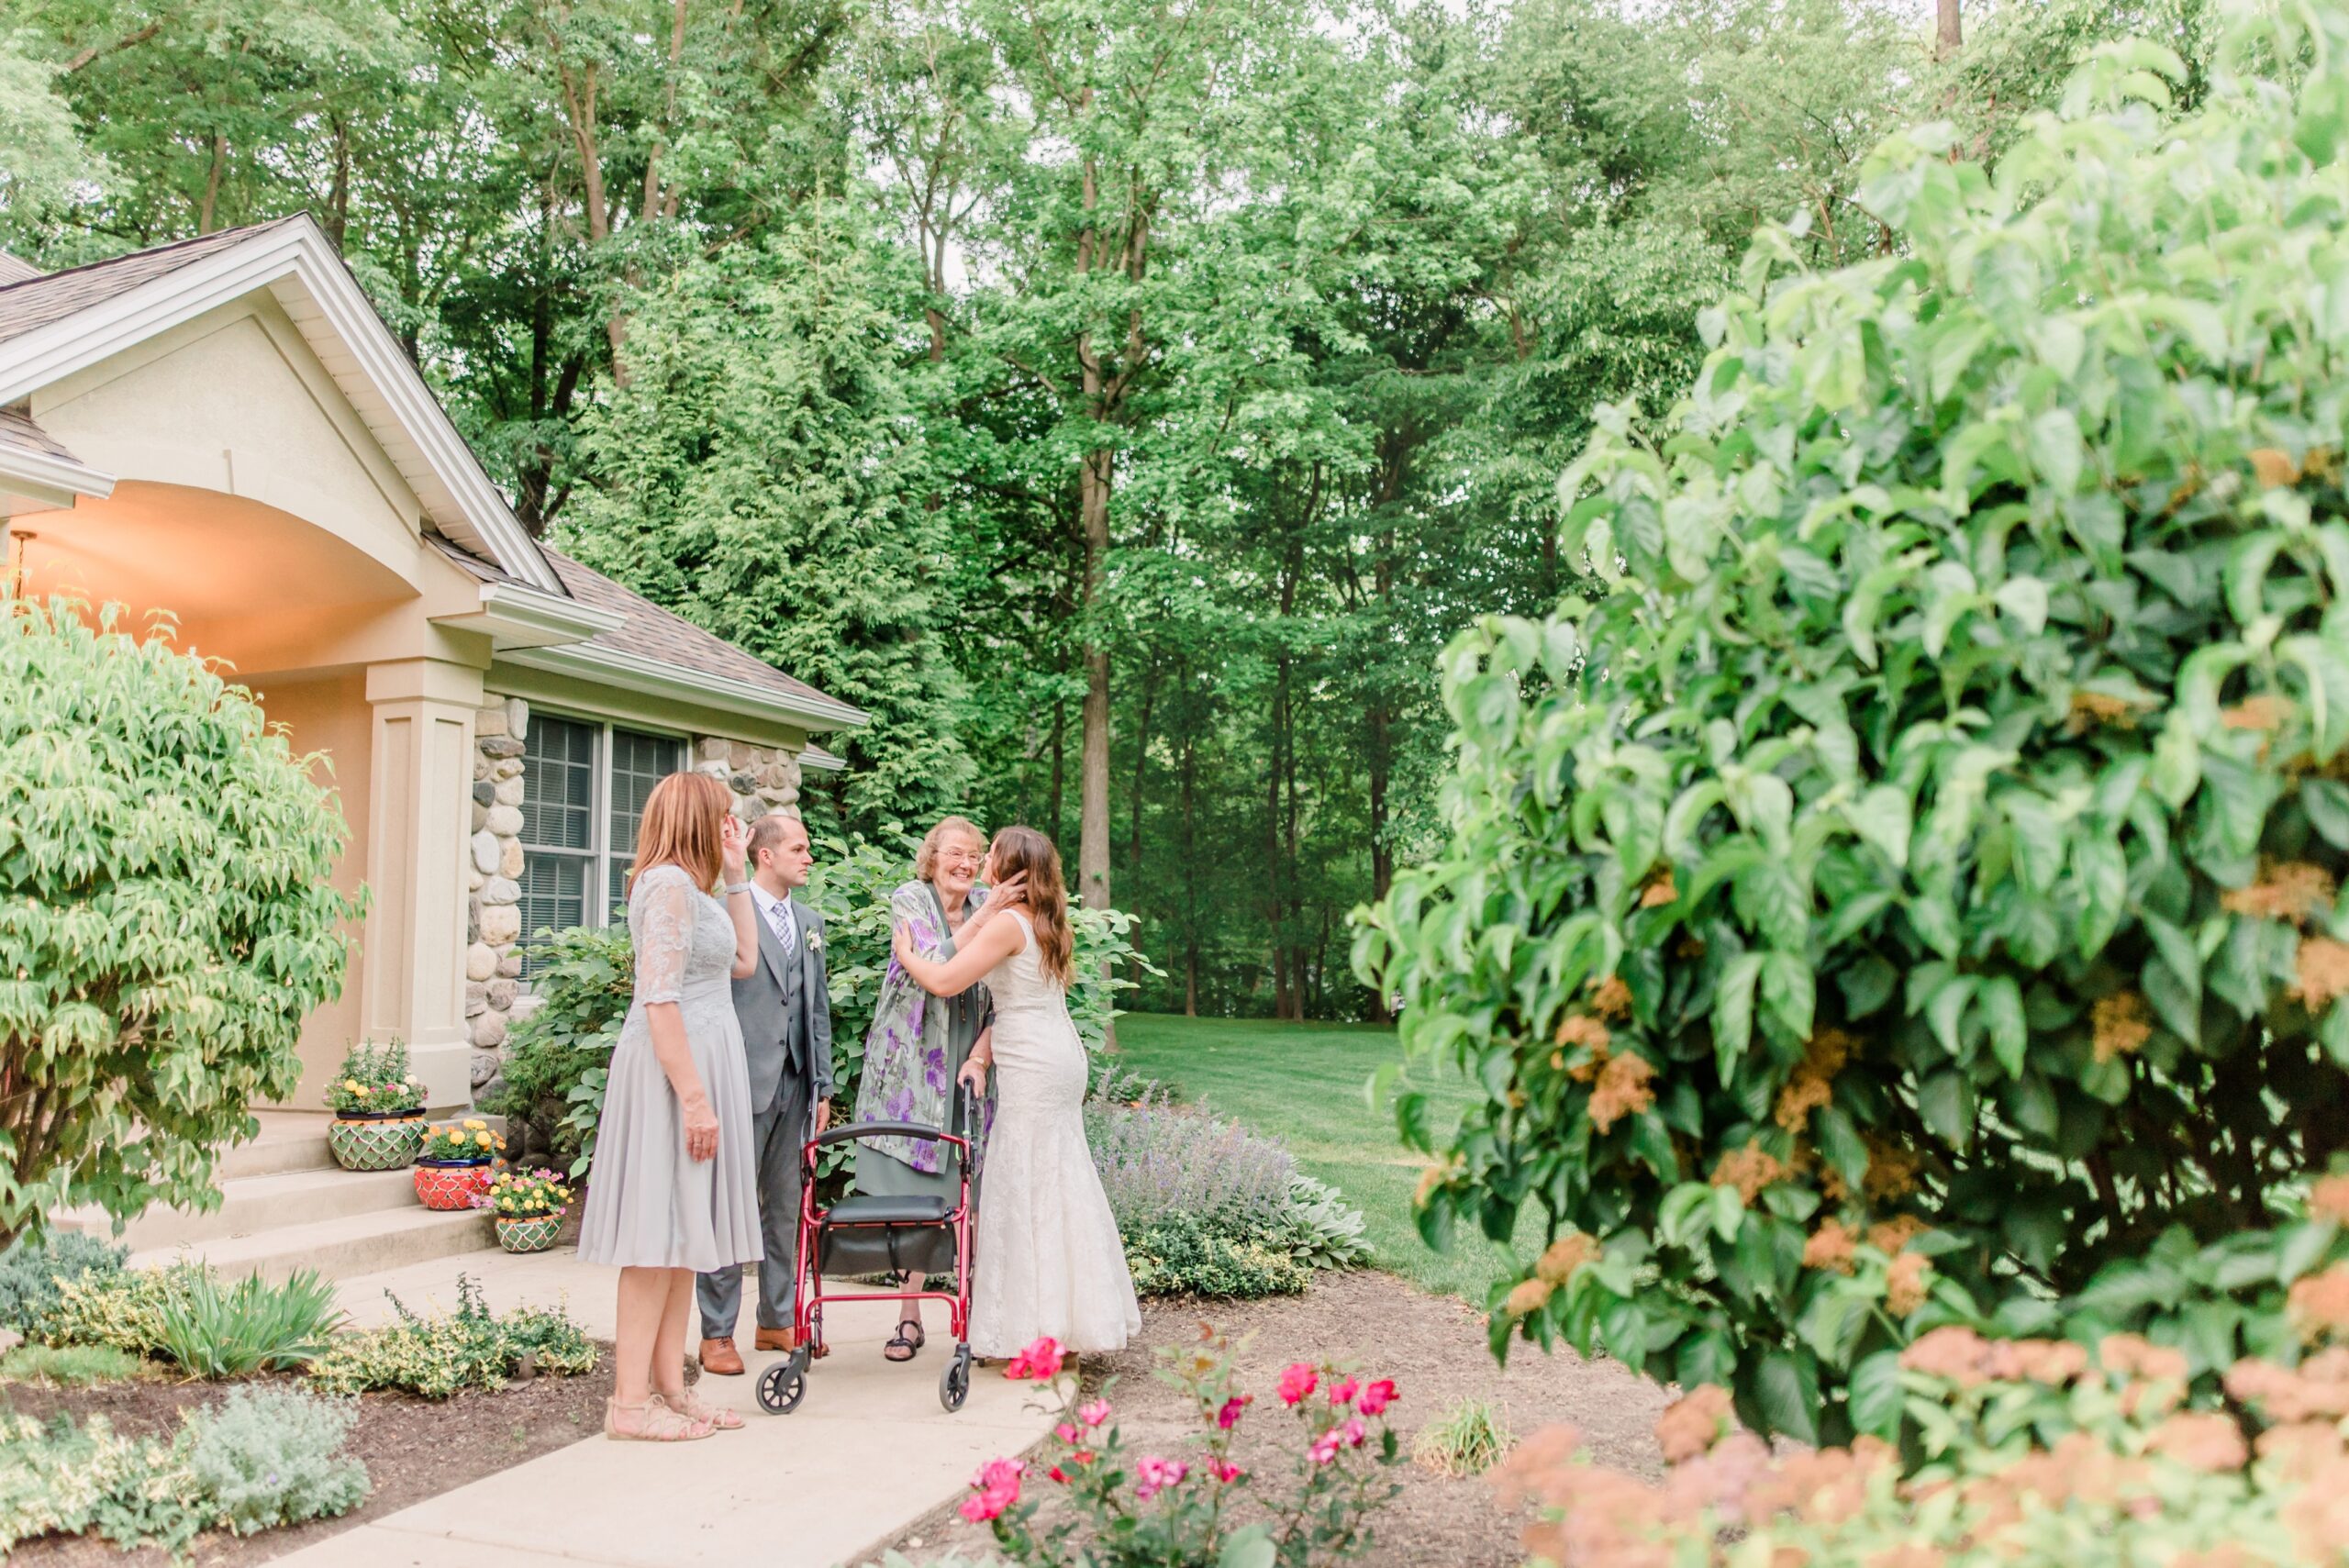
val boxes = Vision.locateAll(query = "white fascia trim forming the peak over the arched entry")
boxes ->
[0,216,569,598]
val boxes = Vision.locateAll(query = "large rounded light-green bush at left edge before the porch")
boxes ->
[0,598,357,1240]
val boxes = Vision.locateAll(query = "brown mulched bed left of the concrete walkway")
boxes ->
[0,1345,611,1568]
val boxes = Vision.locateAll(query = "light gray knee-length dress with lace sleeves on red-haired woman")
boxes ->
[580,866,761,1274]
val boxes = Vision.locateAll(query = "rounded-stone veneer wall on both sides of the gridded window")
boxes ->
[448,697,798,1094]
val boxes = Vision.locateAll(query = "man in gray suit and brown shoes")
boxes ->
[696,812,831,1378]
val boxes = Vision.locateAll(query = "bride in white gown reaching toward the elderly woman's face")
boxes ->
[897,828,1141,1357]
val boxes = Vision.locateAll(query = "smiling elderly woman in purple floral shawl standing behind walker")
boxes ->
[855,817,1019,1362]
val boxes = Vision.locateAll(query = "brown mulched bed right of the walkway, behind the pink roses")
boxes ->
[890,1273,1670,1568]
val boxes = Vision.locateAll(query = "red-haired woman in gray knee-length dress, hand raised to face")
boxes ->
[580,773,761,1443]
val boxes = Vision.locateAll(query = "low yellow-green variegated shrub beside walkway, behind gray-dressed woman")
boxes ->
[310,1274,596,1399]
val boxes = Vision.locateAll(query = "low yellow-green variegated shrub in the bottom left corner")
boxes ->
[0,1411,206,1556]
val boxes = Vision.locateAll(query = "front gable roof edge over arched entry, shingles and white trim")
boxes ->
[0,214,563,594]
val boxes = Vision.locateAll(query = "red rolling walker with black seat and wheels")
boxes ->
[759,1084,980,1416]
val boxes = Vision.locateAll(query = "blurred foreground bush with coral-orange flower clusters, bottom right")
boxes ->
[1501,1314,2349,1568]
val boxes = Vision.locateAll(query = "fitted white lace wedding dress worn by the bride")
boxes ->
[970,911,1141,1357]
